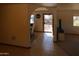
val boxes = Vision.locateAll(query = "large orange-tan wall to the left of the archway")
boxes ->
[0,4,30,47]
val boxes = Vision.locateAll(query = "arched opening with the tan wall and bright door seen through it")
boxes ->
[30,7,53,42]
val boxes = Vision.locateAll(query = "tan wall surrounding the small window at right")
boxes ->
[58,10,79,34]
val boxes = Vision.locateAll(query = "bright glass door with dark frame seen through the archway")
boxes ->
[43,14,53,33]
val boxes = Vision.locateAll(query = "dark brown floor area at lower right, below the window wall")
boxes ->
[57,35,79,56]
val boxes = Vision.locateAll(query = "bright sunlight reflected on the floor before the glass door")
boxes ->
[43,33,53,53]
